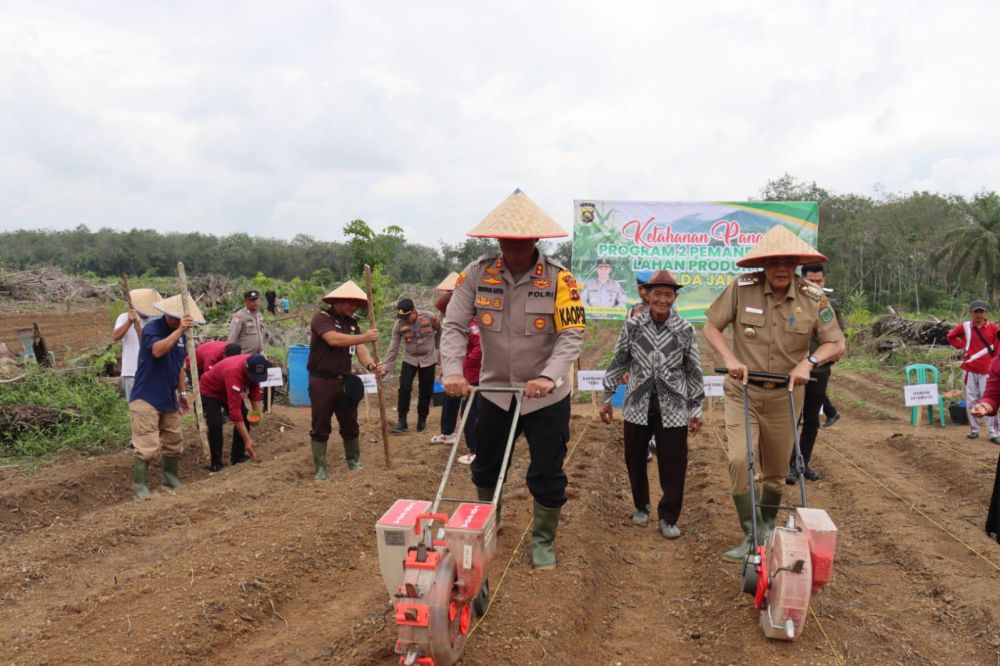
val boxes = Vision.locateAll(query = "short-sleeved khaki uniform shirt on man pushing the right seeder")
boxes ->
[705,272,844,374]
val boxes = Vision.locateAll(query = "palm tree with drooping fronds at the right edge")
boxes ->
[931,192,1000,304]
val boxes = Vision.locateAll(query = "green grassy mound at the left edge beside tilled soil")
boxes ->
[0,368,130,458]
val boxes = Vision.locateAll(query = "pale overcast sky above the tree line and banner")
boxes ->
[0,0,1000,245]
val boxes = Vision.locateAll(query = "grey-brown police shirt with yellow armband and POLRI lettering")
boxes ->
[441,253,586,414]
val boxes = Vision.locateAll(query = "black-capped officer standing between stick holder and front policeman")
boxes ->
[385,298,441,434]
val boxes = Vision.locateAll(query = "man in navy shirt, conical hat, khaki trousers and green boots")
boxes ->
[128,295,205,499]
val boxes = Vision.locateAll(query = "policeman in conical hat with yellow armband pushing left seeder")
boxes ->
[441,190,586,569]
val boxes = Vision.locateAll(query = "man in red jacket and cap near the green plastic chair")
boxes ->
[947,301,1000,444]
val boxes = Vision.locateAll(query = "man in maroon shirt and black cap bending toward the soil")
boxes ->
[201,354,267,472]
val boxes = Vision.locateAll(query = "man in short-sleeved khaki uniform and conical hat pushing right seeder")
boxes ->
[705,226,844,562]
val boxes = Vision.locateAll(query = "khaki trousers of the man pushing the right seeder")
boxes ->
[724,378,804,495]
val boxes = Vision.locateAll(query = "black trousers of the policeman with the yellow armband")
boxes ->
[472,396,576,509]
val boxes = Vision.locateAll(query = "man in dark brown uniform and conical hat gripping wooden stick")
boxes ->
[306,280,383,481]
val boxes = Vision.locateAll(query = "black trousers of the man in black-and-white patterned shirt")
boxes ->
[625,400,687,525]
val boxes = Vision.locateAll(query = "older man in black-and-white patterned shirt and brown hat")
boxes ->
[601,271,705,539]
